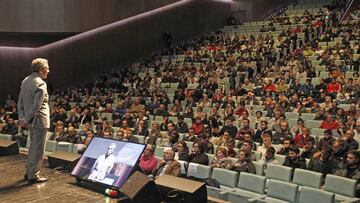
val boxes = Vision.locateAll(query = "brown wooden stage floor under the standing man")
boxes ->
[0,154,107,203]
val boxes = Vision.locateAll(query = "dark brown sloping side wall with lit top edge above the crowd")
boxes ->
[0,0,288,100]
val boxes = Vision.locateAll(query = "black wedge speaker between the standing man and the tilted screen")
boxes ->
[48,151,81,171]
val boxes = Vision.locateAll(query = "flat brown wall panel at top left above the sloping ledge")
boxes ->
[0,0,180,32]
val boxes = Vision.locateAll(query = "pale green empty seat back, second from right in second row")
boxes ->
[293,168,322,188]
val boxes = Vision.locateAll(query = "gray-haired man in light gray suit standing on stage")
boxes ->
[18,58,50,184]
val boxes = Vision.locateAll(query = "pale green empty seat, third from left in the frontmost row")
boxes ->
[227,173,266,203]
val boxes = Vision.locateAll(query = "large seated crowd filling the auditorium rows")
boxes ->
[0,0,360,197]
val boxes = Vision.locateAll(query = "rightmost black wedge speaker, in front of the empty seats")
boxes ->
[155,175,207,203]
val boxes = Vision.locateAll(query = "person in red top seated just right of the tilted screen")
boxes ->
[139,144,158,175]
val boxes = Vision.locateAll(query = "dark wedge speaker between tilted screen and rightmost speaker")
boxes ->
[120,171,161,203]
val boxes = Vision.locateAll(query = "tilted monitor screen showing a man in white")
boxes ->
[71,137,145,188]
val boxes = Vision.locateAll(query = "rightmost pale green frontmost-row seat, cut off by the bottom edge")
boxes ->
[298,186,335,203]
